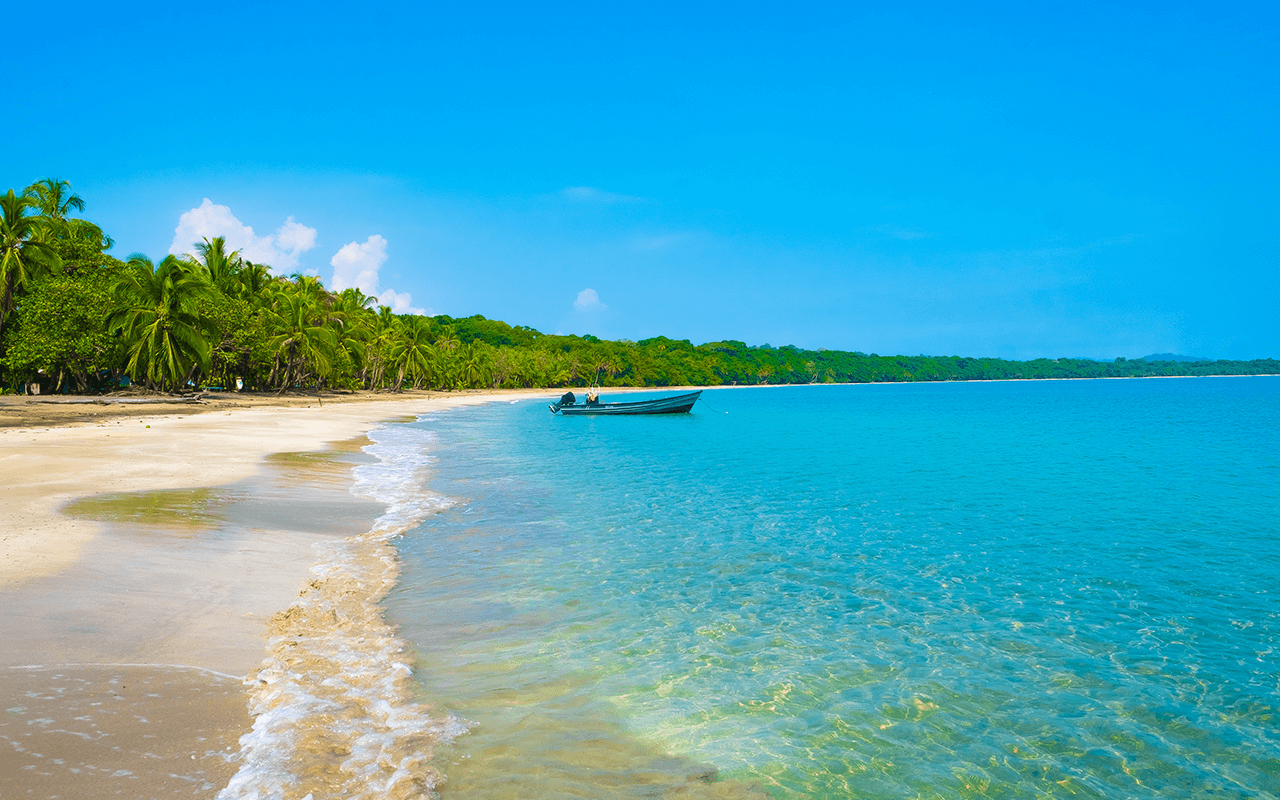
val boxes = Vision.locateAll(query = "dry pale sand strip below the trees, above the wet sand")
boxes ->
[0,390,545,589]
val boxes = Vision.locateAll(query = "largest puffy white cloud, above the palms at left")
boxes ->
[169,197,316,273]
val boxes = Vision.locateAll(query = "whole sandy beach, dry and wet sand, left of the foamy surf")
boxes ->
[0,392,545,797]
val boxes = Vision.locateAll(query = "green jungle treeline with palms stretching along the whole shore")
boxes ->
[0,178,1280,393]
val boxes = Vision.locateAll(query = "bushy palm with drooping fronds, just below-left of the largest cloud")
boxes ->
[108,253,211,390]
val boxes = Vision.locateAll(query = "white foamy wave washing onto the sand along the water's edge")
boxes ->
[218,426,468,800]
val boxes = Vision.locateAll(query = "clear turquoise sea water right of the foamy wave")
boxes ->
[389,378,1280,799]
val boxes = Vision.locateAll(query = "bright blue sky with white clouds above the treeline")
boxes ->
[0,0,1280,358]
